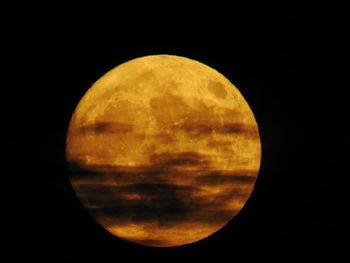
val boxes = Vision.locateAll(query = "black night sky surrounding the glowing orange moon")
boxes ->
[2,1,349,262]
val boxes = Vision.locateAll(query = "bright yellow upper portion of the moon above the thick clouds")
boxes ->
[67,55,260,172]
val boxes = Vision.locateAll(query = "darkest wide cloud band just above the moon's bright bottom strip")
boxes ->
[75,175,249,231]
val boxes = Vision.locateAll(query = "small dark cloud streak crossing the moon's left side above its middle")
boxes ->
[79,122,133,134]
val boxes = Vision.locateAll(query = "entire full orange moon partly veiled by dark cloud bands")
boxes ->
[66,55,261,247]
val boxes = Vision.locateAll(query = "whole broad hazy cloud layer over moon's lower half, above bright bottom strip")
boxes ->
[71,152,256,239]
